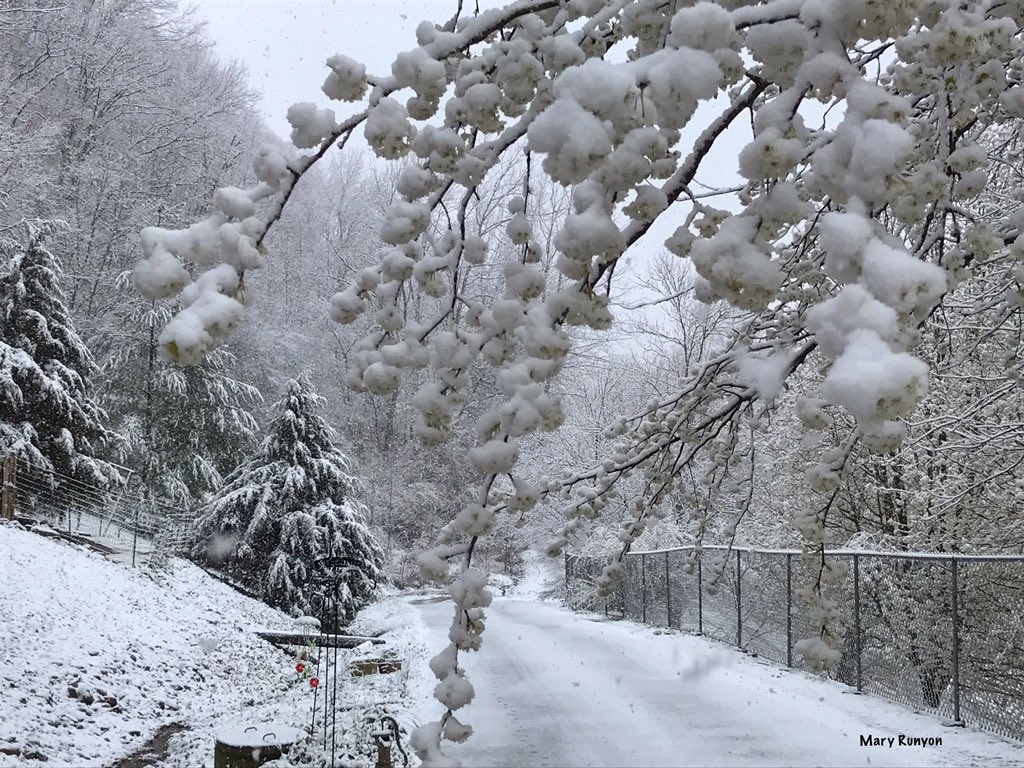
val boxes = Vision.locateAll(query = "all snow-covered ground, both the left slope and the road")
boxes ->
[6,525,1024,768]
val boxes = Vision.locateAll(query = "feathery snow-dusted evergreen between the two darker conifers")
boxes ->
[101,301,262,505]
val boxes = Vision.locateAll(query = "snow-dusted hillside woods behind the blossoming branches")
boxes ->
[0,0,1024,593]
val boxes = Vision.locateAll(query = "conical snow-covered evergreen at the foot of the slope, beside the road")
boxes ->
[194,375,383,624]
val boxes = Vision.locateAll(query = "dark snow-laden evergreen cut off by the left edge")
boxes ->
[0,222,117,482]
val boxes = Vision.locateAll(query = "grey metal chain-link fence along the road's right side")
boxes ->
[565,547,1024,739]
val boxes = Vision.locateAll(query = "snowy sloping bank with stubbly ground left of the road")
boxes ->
[0,525,425,768]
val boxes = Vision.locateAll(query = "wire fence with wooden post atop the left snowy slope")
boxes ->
[4,457,193,565]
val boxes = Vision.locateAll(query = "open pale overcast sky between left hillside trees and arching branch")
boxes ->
[193,0,460,136]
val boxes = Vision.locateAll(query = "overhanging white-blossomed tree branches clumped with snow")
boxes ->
[134,0,1024,765]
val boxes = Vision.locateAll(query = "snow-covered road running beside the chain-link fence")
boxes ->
[417,598,1024,768]
